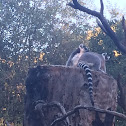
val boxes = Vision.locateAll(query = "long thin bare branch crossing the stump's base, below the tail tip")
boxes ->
[51,105,126,126]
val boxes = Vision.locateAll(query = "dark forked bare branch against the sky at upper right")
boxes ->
[68,0,126,53]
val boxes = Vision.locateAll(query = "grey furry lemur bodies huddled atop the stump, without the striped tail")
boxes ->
[66,44,110,73]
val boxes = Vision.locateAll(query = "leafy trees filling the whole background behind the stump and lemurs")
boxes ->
[0,0,126,126]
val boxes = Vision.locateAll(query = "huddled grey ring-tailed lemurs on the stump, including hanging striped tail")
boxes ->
[66,44,110,105]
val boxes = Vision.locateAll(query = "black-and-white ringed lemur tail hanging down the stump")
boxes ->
[78,62,94,106]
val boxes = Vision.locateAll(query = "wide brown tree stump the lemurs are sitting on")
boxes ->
[24,66,117,126]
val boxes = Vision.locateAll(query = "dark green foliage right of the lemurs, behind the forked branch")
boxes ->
[89,20,126,126]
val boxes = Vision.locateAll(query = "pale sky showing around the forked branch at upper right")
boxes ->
[56,0,126,27]
